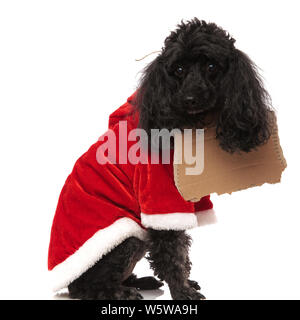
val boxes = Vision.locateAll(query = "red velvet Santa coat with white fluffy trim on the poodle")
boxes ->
[48,94,215,291]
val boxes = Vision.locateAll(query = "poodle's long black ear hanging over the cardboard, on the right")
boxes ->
[216,49,272,152]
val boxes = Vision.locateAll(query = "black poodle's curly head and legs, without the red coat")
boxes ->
[68,18,271,300]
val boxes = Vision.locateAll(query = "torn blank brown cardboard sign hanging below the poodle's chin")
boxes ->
[173,114,286,201]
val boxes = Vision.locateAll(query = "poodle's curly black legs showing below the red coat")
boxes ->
[68,229,204,300]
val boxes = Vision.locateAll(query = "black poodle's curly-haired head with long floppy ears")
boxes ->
[136,18,271,152]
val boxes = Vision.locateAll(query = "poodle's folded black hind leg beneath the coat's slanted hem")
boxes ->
[68,237,146,300]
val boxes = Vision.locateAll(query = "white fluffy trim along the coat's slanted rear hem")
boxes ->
[50,218,147,291]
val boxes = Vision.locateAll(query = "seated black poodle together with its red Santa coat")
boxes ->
[49,18,271,300]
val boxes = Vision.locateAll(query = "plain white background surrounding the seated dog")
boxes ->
[0,0,300,299]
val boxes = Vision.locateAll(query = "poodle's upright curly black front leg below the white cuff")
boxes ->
[147,229,205,300]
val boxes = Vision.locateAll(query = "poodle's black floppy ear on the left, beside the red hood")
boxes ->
[136,55,174,131]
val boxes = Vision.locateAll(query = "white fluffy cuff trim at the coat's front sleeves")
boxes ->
[141,209,216,230]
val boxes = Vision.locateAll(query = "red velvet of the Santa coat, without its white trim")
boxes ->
[48,96,213,270]
